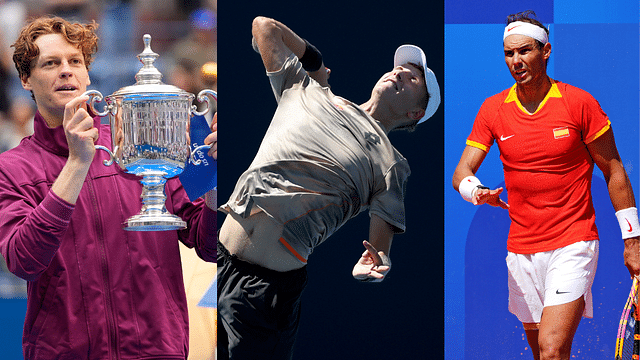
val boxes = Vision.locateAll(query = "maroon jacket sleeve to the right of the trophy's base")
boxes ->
[167,178,218,262]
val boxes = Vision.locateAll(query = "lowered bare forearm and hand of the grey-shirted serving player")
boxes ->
[352,214,394,282]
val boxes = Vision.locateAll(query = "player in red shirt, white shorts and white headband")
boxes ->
[453,11,640,359]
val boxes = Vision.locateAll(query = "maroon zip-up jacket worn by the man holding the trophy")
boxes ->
[0,114,216,360]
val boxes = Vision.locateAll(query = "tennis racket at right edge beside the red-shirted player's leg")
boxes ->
[616,276,640,360]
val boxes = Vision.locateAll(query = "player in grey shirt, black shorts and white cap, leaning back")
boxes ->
[218,17,440,359]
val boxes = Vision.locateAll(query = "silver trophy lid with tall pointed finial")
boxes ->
[111,34,194,97]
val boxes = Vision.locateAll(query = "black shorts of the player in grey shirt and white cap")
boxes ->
[217,242,307,360]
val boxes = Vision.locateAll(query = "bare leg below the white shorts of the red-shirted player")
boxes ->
[538,296,585,360]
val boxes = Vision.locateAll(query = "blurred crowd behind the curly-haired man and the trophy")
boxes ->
[0,0,217,299]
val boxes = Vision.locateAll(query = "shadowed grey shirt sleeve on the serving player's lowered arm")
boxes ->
[369,160,410,233]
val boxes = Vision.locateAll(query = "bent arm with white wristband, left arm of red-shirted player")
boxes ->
[452,145,509,209]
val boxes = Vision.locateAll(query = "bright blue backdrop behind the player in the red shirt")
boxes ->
[444,0,639,359]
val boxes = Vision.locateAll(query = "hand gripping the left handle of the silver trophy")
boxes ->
[62,95,98,164]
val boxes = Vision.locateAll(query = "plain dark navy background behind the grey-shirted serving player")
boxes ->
[218,0,444,360]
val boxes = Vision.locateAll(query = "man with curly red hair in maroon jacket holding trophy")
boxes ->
[0,18,217,359]
